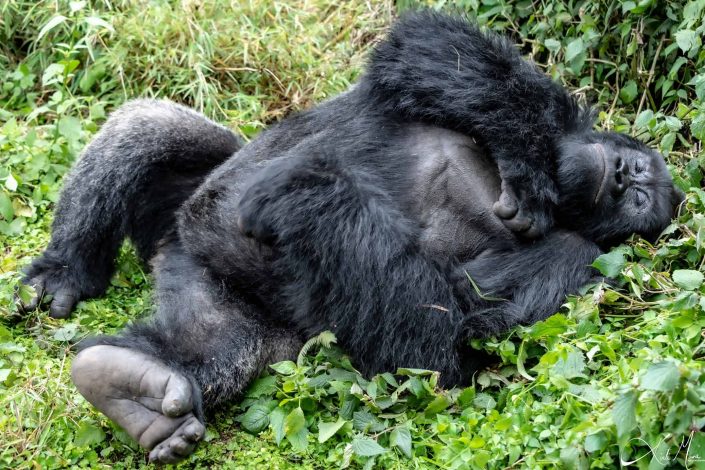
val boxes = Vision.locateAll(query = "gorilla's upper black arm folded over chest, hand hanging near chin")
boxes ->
[361,11,593,237]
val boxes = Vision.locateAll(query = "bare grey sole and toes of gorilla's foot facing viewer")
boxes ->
[71,345,205,463]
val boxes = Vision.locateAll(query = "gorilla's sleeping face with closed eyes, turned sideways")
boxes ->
[557,133,684,245]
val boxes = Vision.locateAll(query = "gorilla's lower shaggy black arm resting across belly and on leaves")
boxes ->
[231,150,598,385]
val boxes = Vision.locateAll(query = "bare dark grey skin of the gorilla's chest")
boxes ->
[408,124,516,260]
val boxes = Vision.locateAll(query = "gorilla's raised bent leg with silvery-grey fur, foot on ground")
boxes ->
[25,100,241,317]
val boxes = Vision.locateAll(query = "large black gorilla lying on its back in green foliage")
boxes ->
[25,12,681,462]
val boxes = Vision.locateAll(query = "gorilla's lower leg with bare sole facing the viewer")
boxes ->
[72,242,301,463]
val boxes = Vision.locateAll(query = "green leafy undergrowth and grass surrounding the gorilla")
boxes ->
[0,0,705,469]
